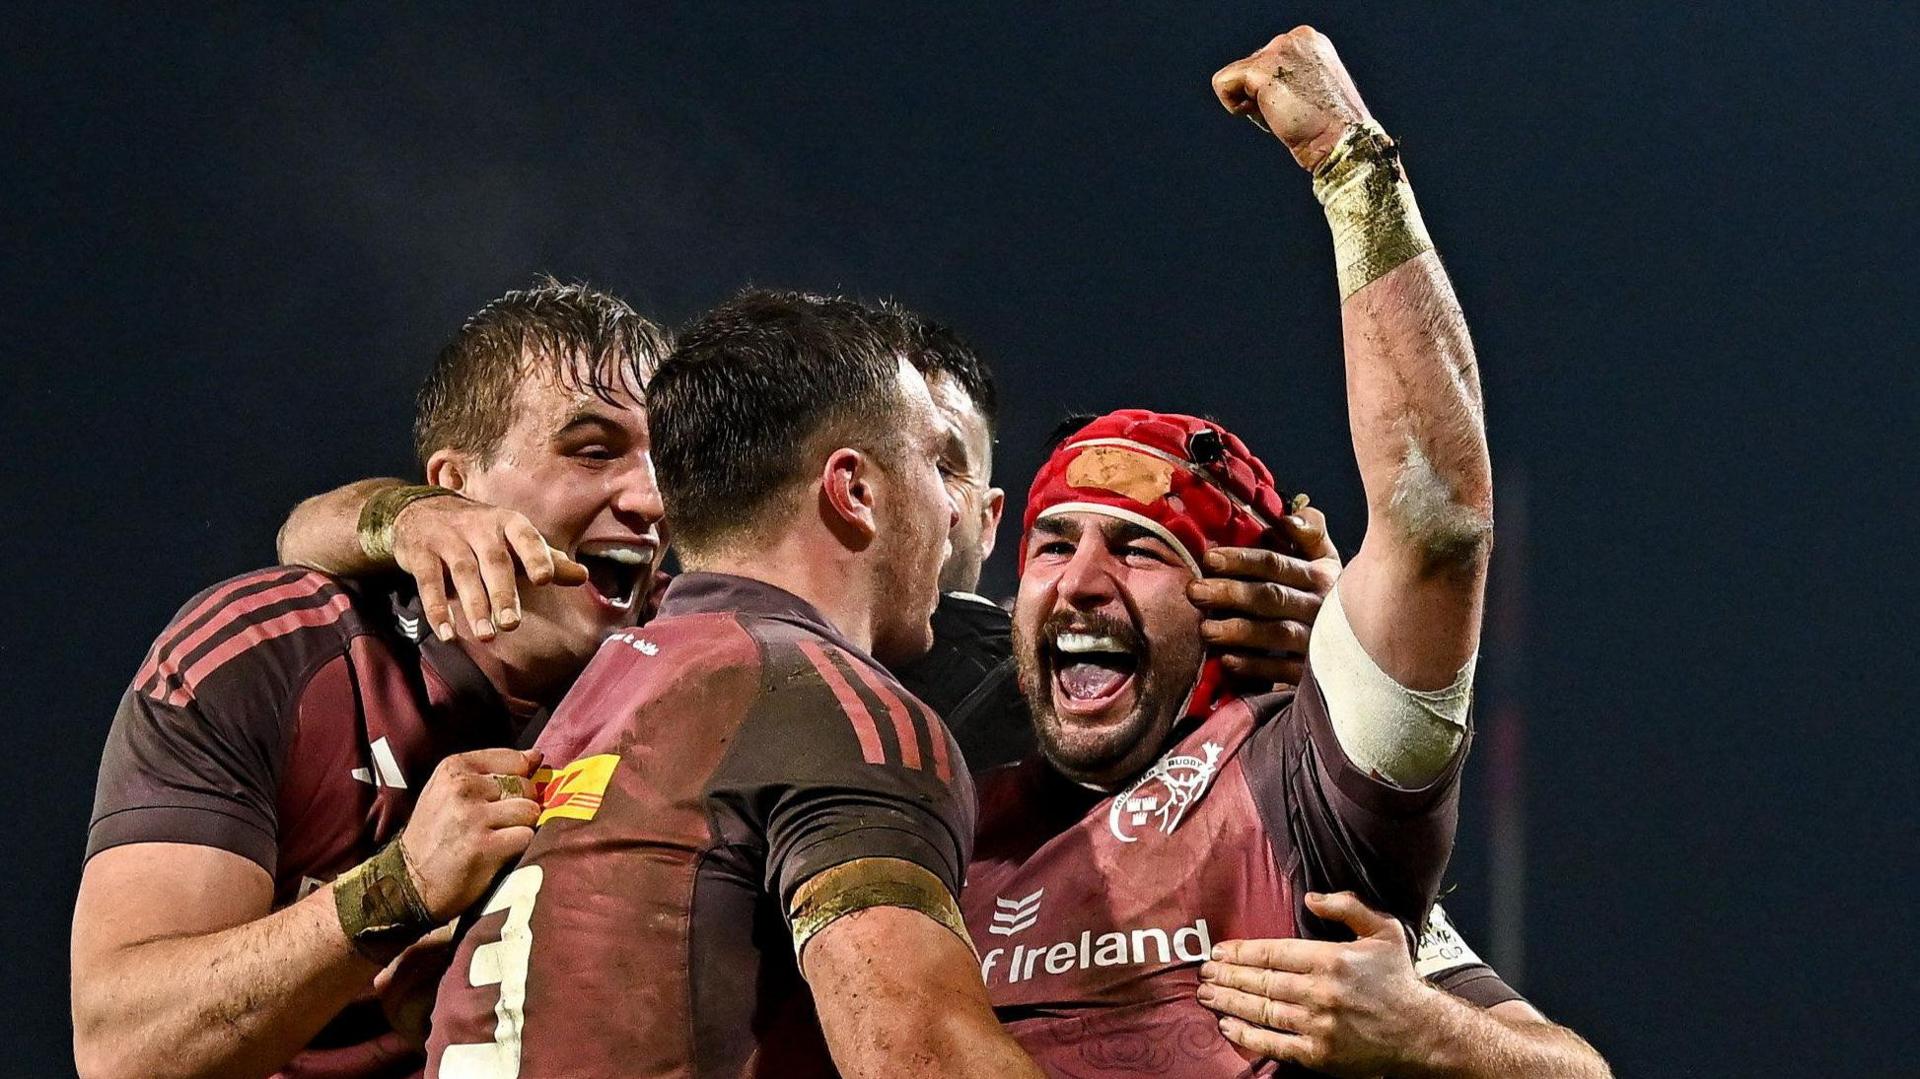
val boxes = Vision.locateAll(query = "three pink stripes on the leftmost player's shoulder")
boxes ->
[129,566,365,707]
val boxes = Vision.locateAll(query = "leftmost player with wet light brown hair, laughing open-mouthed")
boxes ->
[71,282,668,1077]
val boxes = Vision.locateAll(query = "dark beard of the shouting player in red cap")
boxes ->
[1014,599,1202,787]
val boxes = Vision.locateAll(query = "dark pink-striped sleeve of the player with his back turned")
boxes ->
[718,639,975,912]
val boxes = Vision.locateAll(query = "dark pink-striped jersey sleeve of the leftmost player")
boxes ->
[86,568,348,874]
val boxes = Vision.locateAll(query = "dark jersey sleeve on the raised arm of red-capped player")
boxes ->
[1248,660,1467,937]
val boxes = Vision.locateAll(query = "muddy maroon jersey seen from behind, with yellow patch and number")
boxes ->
[428,574,973,1079]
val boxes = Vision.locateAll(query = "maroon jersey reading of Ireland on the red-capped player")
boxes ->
[960,672,1465,1077]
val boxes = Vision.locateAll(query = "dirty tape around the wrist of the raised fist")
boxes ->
[1313,119,1434,303]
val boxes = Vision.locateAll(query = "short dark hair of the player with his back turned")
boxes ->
[647,288,906,555]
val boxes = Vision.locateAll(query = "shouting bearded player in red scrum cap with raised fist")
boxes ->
[962,27,1605,1075]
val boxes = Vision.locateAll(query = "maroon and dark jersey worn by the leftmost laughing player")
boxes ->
[86,566,518,1079]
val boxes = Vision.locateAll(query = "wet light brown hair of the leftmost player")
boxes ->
[413,276,674,465]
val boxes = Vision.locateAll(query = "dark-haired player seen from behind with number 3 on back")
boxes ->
[428,290,1037,1079]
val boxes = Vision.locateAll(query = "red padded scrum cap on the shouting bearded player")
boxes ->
[1020,409,1286,714]
